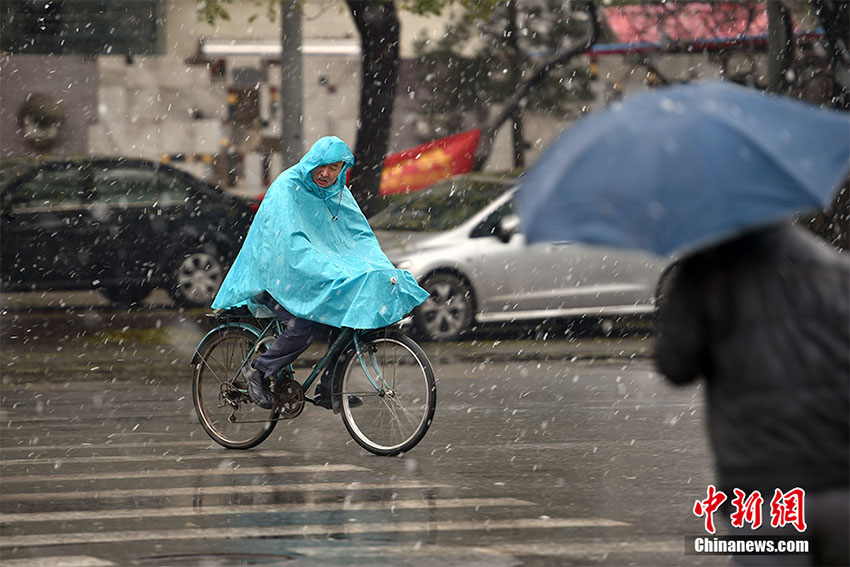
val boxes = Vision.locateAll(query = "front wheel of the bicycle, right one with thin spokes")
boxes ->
[337,331,437,456]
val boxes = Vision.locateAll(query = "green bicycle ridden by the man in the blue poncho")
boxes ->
[192,310,437,456]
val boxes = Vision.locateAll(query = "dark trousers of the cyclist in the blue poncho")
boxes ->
[254,294,339,393]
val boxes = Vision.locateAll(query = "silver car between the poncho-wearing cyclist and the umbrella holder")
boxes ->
[369,174,664,340]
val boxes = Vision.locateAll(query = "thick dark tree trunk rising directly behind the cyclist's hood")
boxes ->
[346,0,400,217]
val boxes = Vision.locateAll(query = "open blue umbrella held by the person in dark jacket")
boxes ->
[515,81,850,255]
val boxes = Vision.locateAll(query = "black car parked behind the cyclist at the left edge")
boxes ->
[0,158,254,307]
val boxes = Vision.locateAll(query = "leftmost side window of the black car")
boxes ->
[9,168,86,211]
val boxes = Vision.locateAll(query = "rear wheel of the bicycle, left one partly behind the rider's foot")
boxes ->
[192,325,280,449]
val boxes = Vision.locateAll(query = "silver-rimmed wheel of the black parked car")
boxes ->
[170,246,225,307]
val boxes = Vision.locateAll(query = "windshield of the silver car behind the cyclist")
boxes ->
[369,177,511,232]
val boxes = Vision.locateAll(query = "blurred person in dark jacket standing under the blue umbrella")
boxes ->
[655,224,850,565]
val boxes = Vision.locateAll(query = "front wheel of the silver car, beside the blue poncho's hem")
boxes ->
[413,273,475,341]
